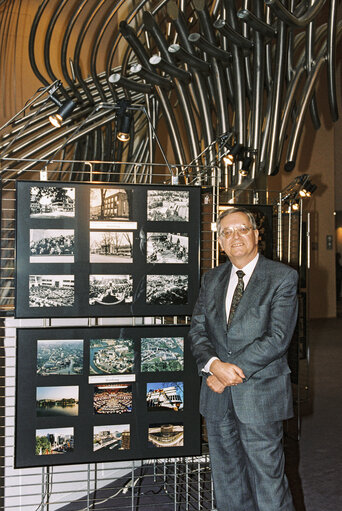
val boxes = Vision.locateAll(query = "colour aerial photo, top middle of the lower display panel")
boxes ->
[89,339,134,374]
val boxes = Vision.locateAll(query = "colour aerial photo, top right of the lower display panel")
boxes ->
[141,337,184,372]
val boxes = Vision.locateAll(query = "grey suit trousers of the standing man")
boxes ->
[206,389,295,511]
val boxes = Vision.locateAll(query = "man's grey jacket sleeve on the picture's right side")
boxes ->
[229,269,298,380]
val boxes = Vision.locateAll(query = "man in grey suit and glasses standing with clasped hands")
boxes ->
[190,208,298,511]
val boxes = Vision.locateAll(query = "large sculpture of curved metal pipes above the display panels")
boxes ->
[0,0,342,190]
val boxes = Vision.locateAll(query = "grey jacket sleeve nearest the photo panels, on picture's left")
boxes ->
[188,275,217,374]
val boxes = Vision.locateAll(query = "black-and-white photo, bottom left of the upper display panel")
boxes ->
[29,275,75,307]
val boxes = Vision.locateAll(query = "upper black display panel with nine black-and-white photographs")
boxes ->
[16,181,200,318]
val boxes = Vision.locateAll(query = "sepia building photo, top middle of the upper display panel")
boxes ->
[90,188,129,221]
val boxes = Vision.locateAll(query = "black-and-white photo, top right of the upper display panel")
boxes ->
[147,190,189,222]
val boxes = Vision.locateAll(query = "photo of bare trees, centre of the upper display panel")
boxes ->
[90,231,133,263]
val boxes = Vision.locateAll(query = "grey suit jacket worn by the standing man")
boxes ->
[189,254,298,424]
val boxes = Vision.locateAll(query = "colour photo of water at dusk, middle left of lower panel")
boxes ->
[36,386,79,417]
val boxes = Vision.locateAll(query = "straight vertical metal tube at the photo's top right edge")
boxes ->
[328,0,338,122]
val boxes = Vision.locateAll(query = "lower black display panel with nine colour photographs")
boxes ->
[15,325,200,468]
